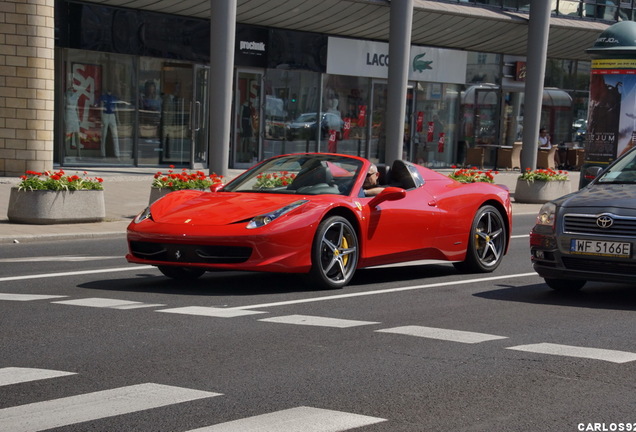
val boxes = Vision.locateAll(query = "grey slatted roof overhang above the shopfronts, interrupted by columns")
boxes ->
[74,0,609,60]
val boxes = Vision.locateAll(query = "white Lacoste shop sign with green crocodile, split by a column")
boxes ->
[327,37,468,84]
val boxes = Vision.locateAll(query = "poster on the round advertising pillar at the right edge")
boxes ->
[585,59,636,164]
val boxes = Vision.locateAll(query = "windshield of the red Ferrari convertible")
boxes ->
[222,154,362,195]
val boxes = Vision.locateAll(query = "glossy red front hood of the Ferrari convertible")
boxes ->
[151,190,308,226]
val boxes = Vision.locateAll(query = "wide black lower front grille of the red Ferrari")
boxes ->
[130,241,252,264]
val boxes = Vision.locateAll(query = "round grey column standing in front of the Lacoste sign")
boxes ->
[384,0,413,164]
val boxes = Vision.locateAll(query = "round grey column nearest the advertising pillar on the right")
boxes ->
[521,0,551,172]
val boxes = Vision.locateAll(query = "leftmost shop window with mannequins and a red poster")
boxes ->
[62,50,137,164]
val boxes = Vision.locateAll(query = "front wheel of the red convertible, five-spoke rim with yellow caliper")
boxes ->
[309,216,359,289]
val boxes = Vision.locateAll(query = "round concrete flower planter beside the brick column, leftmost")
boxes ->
[7,188,106,225]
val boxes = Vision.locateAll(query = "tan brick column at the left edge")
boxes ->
[0,0,55,176]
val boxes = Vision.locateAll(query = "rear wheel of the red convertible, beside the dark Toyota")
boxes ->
[453,205,508,273]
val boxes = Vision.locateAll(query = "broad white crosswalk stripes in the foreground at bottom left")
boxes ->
[0,367,386,432]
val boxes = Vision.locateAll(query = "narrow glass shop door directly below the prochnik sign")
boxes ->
[232,70,263,168]
